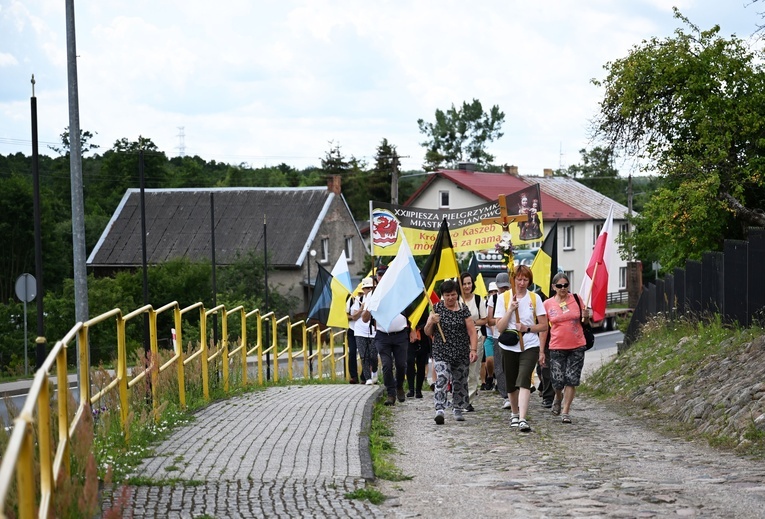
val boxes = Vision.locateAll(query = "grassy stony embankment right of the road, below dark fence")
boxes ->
[580,316,765,458]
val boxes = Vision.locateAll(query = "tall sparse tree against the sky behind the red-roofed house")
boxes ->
[417,99,505,171]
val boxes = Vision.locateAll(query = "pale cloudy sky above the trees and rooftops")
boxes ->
[0,0,765,176]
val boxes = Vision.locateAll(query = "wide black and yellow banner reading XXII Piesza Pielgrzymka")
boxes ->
[369,184,544,256]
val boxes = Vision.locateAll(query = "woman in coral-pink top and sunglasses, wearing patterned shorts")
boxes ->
[544,272,589,423]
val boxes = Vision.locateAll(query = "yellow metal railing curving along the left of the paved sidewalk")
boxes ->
[0,302,355,519]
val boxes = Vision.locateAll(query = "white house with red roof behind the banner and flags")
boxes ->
[404,164,628,292]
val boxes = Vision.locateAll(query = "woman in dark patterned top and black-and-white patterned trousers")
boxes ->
[425,279,477,425]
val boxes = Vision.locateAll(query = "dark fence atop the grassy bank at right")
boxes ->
[624,227,765,345]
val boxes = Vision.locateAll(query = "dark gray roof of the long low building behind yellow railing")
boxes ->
[87,187,336,267]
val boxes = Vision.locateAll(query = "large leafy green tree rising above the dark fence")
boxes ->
[594,10,765,268]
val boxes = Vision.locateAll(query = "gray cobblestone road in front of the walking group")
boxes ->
[377,393,765,518]
